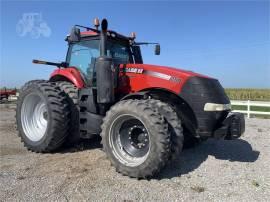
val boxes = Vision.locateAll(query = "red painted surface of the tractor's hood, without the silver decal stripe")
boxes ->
[119,64,209,94]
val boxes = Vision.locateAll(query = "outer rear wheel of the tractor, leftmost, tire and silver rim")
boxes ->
[16,81,70,152]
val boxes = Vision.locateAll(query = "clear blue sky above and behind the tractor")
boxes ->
[0,0,270,88]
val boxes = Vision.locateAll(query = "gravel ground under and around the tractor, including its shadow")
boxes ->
[0,104,270,201]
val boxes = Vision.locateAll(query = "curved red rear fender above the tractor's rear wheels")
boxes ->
[51,67,84,88]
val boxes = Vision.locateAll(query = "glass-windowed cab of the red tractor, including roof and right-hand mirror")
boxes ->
[66,19,160,86]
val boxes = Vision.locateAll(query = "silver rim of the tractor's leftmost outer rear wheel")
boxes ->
[21,94,48,142]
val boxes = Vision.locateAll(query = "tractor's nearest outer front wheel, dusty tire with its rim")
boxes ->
[101,100,171,178]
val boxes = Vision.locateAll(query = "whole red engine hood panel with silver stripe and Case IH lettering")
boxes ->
[119,64,216,94]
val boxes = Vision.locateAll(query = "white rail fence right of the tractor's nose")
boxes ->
[231,100,270,118]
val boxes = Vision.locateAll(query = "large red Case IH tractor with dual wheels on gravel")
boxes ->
[16,19,245,178]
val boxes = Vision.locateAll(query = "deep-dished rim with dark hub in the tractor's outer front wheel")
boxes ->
[109,114,151,167]
